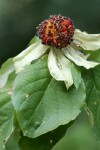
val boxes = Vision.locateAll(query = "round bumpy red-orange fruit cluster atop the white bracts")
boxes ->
[37,15,74,49]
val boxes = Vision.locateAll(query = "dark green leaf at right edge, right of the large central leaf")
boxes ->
[84,65,100,140]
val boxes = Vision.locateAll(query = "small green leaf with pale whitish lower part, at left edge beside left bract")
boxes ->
[0,58,14,88]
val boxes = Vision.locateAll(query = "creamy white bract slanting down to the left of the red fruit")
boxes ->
[13,40,48,73]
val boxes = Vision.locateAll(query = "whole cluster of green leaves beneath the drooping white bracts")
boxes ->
[0,39,100,150]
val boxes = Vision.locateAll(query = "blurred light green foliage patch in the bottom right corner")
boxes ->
[53,112,100,150]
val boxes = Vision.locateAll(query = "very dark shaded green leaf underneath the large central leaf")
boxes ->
[19,122,72,150]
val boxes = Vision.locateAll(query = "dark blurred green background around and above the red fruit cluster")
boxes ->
[0,0,100,65]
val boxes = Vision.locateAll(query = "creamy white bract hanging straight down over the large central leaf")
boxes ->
[48,48,73,88]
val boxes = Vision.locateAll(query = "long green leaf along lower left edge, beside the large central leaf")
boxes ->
[0,72,15,150]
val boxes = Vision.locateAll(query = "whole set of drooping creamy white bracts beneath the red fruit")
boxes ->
[13,29,100,89]
